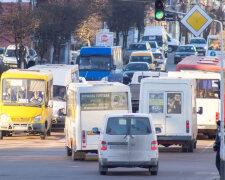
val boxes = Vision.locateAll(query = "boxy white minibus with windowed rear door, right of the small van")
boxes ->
[139,77,198,152]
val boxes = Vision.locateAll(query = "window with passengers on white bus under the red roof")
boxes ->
[196,79,219,99]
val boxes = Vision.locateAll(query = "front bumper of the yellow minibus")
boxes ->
[0,123,45,132]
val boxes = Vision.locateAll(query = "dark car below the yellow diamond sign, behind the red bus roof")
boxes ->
[174,45,198,64]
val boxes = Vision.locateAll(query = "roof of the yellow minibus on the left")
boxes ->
[2,69,52,78]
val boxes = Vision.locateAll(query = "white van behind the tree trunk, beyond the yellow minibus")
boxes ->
[3,45,29,68]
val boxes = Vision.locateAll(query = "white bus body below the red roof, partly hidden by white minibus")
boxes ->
[168,70,220,138]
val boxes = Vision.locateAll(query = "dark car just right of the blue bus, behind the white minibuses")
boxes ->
[123,62,149,84]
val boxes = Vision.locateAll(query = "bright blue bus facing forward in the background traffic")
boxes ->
[76,46,123,81]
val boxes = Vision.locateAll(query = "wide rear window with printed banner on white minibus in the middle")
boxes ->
[80,92,128,111]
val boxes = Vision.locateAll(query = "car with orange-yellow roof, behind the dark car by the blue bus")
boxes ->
[129,51,155,70]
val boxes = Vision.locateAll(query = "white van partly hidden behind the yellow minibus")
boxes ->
[29,64,79,128]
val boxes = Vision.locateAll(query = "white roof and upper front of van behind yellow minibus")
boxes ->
[29,64,78,86]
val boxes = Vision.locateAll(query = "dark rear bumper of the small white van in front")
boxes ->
[99,158,158,168]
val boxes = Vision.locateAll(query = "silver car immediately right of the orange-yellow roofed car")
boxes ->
[153,52,167,72]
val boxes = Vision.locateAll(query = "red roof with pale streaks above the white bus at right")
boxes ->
[176,56,225,72]
